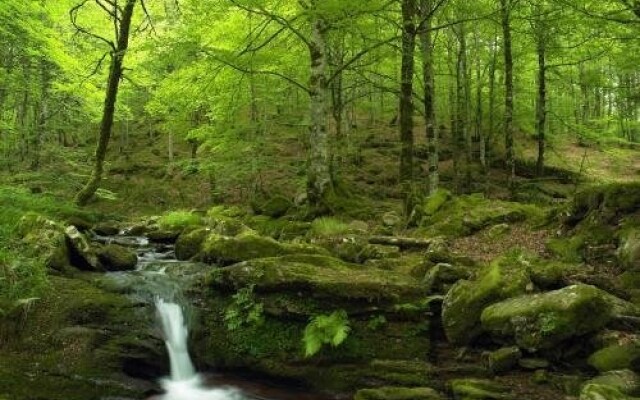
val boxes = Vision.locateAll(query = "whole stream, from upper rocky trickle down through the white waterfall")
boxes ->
[94,235,327,400]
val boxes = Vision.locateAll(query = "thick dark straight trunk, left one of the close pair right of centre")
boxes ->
[400,0,416,215]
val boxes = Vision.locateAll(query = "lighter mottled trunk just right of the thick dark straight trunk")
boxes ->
[420,0,440,194]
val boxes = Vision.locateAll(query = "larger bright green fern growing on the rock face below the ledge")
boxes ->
[302,310,351,357]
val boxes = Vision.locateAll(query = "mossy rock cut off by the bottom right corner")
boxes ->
[580,370,640,400]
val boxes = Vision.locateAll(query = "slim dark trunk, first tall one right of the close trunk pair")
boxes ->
[500,0,516,187]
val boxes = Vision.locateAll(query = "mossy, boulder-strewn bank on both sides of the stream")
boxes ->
[0,183,640,400]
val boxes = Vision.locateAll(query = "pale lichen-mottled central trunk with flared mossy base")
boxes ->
[307,10,333,212]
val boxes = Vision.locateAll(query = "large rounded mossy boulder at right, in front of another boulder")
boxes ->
[481,285,611,351]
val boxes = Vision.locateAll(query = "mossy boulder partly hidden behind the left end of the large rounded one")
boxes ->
[442,258,531,344]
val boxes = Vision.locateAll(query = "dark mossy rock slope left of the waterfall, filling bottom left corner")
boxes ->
[0,276,161,400]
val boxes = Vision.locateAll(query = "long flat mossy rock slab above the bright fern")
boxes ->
[210,255,425,301]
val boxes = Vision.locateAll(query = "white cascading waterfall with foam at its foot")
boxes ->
[156,298,244,400]
